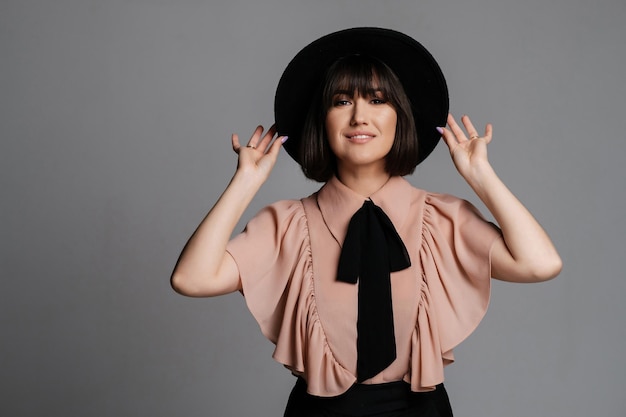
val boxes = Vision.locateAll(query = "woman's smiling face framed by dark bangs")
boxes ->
[326,91,397,173]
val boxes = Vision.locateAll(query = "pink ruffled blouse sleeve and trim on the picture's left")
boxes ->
[228,201,356,397]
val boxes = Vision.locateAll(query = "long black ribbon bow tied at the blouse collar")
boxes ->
[337,200,411,382]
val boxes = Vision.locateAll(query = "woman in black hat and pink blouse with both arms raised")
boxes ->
[172,28,561,416]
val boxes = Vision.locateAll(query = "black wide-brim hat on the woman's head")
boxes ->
[274,27,449,164]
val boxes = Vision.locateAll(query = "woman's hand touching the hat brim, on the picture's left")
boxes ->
[232,126,287,183]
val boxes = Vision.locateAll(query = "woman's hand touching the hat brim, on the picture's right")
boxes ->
[442,114,493,179]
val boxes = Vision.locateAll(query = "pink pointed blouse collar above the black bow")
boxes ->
[317,176,413,245]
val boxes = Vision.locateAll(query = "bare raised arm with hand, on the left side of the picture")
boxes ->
[171,126,286,297]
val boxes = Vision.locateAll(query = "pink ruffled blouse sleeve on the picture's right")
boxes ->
[408,194,501,391]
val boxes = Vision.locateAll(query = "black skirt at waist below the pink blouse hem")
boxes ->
[284,378,452,417]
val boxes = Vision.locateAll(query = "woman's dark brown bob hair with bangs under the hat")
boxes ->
[299,55,420,182]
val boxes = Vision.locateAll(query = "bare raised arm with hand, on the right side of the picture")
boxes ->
[441,115,562,282]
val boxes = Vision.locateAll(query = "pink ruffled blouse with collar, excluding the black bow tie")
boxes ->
[228,177,501,396]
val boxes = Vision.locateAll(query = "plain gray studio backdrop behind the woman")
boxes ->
[0,0,626,417]
